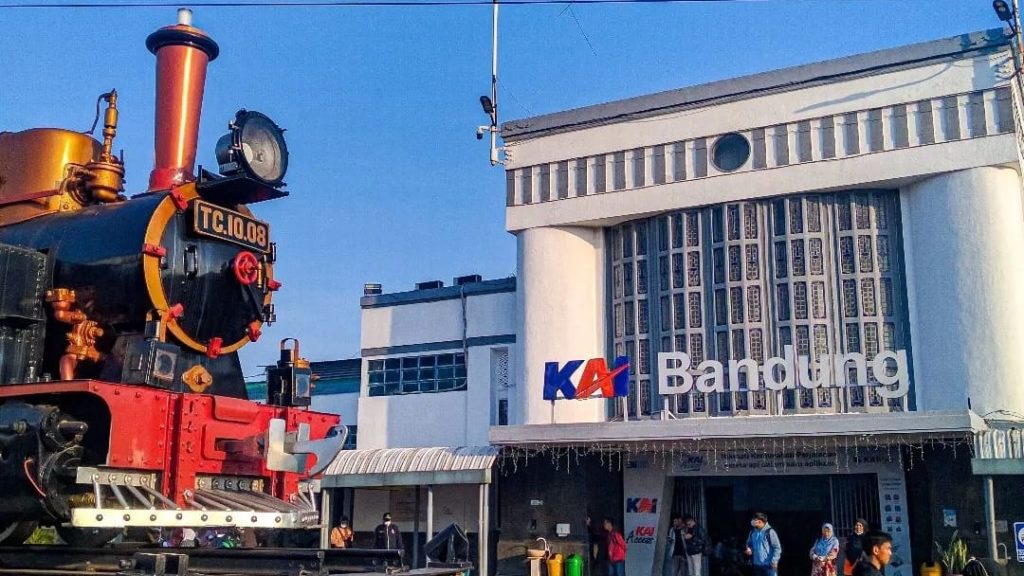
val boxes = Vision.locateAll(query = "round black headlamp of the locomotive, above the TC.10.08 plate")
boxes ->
[217,110,288,188]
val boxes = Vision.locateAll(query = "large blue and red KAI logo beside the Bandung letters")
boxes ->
[544,356,630,401]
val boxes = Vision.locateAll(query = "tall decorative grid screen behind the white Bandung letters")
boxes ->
[607,191,912,417]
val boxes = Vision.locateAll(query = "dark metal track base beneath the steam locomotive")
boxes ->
[0,546,465,576]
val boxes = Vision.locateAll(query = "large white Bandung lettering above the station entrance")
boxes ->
[657,346,910,399]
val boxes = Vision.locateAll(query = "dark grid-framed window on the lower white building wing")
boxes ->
[367,353,466,397]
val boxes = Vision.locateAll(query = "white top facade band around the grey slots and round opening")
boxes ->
[506,47,1017,232]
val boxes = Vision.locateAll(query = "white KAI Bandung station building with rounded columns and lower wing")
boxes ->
[311,30,1024,576]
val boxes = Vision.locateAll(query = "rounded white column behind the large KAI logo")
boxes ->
[514,228,606,424]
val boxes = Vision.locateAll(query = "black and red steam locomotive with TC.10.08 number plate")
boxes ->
[0,9,344,545]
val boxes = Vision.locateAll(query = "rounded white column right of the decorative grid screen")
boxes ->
[900,163,1024,415]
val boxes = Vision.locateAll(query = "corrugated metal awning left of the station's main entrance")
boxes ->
[319,446,500,488]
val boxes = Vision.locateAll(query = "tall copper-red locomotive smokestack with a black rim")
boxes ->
[145,8,220,191]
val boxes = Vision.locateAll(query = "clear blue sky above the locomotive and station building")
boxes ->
[0,0,1000,374]
